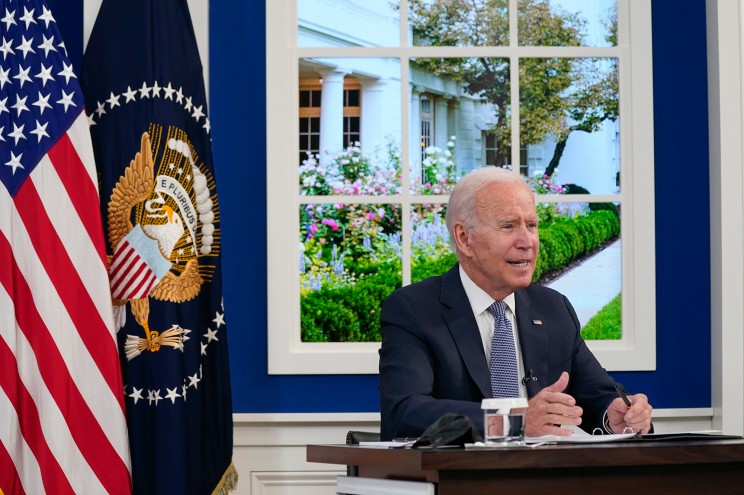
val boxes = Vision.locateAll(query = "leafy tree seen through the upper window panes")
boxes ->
[408,0,618,175]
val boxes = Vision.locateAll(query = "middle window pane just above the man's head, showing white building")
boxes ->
[409,57,511,194]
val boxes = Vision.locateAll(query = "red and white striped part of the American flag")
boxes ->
[0,113,131,495]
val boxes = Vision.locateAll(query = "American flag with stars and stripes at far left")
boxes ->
[0,0,131,495]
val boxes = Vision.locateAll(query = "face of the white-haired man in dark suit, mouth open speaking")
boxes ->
[456,183,540,299]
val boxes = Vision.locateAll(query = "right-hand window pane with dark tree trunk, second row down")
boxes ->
[519,58,620,194]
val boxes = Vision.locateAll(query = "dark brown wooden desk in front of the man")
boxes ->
[307,439,744,495]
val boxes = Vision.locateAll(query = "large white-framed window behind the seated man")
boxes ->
[267,0,655,374]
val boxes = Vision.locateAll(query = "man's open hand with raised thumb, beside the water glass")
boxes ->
[524,371,583,437]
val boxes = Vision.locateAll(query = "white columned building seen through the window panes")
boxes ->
[298,0,620,194]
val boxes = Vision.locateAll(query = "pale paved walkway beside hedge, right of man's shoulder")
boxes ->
[548,239,622,326]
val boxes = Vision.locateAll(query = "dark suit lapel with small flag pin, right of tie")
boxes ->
[514,290,550,397]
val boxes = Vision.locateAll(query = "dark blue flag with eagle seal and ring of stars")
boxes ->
[81,0,237,494]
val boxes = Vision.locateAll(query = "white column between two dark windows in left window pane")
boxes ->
[320,69,347,162]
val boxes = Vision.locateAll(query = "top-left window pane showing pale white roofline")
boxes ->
[297,0,400,47]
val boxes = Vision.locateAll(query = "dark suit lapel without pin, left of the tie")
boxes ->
[440,264,492,397]
